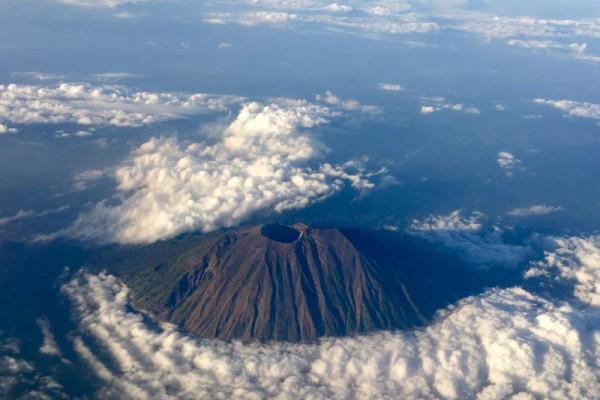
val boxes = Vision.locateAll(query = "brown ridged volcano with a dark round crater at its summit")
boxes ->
[102,224,516,342]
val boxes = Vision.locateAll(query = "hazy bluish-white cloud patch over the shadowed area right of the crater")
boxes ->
[408,210,530,267]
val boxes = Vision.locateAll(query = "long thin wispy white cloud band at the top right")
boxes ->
[198,0,600,63]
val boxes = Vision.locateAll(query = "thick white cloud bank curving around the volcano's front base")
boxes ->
[63,238,600,400]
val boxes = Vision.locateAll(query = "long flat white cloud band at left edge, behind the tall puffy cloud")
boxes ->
[0,83,241,127]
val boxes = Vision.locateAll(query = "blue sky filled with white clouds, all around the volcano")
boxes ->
[0,0,600,399]
